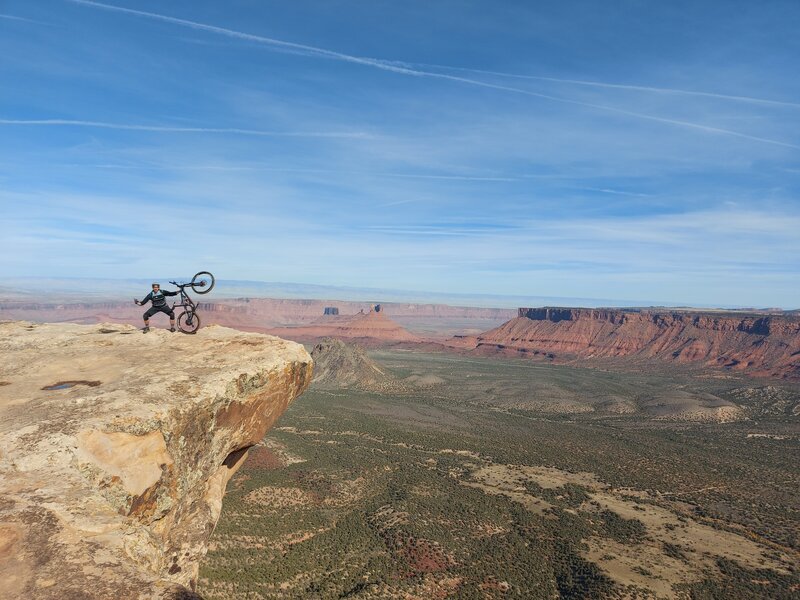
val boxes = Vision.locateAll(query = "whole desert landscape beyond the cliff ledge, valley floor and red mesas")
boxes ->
[0,290,800,599]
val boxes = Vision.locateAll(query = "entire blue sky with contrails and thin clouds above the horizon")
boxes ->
[0,0,800,308]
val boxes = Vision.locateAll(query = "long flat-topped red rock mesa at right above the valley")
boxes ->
[474,307,800,379]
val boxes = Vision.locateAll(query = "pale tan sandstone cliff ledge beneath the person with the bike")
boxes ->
[0,322,312,600]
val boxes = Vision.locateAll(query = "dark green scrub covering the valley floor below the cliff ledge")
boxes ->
[200,352,800,600]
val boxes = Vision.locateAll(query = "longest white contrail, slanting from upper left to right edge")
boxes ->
[67,0,800,150]
